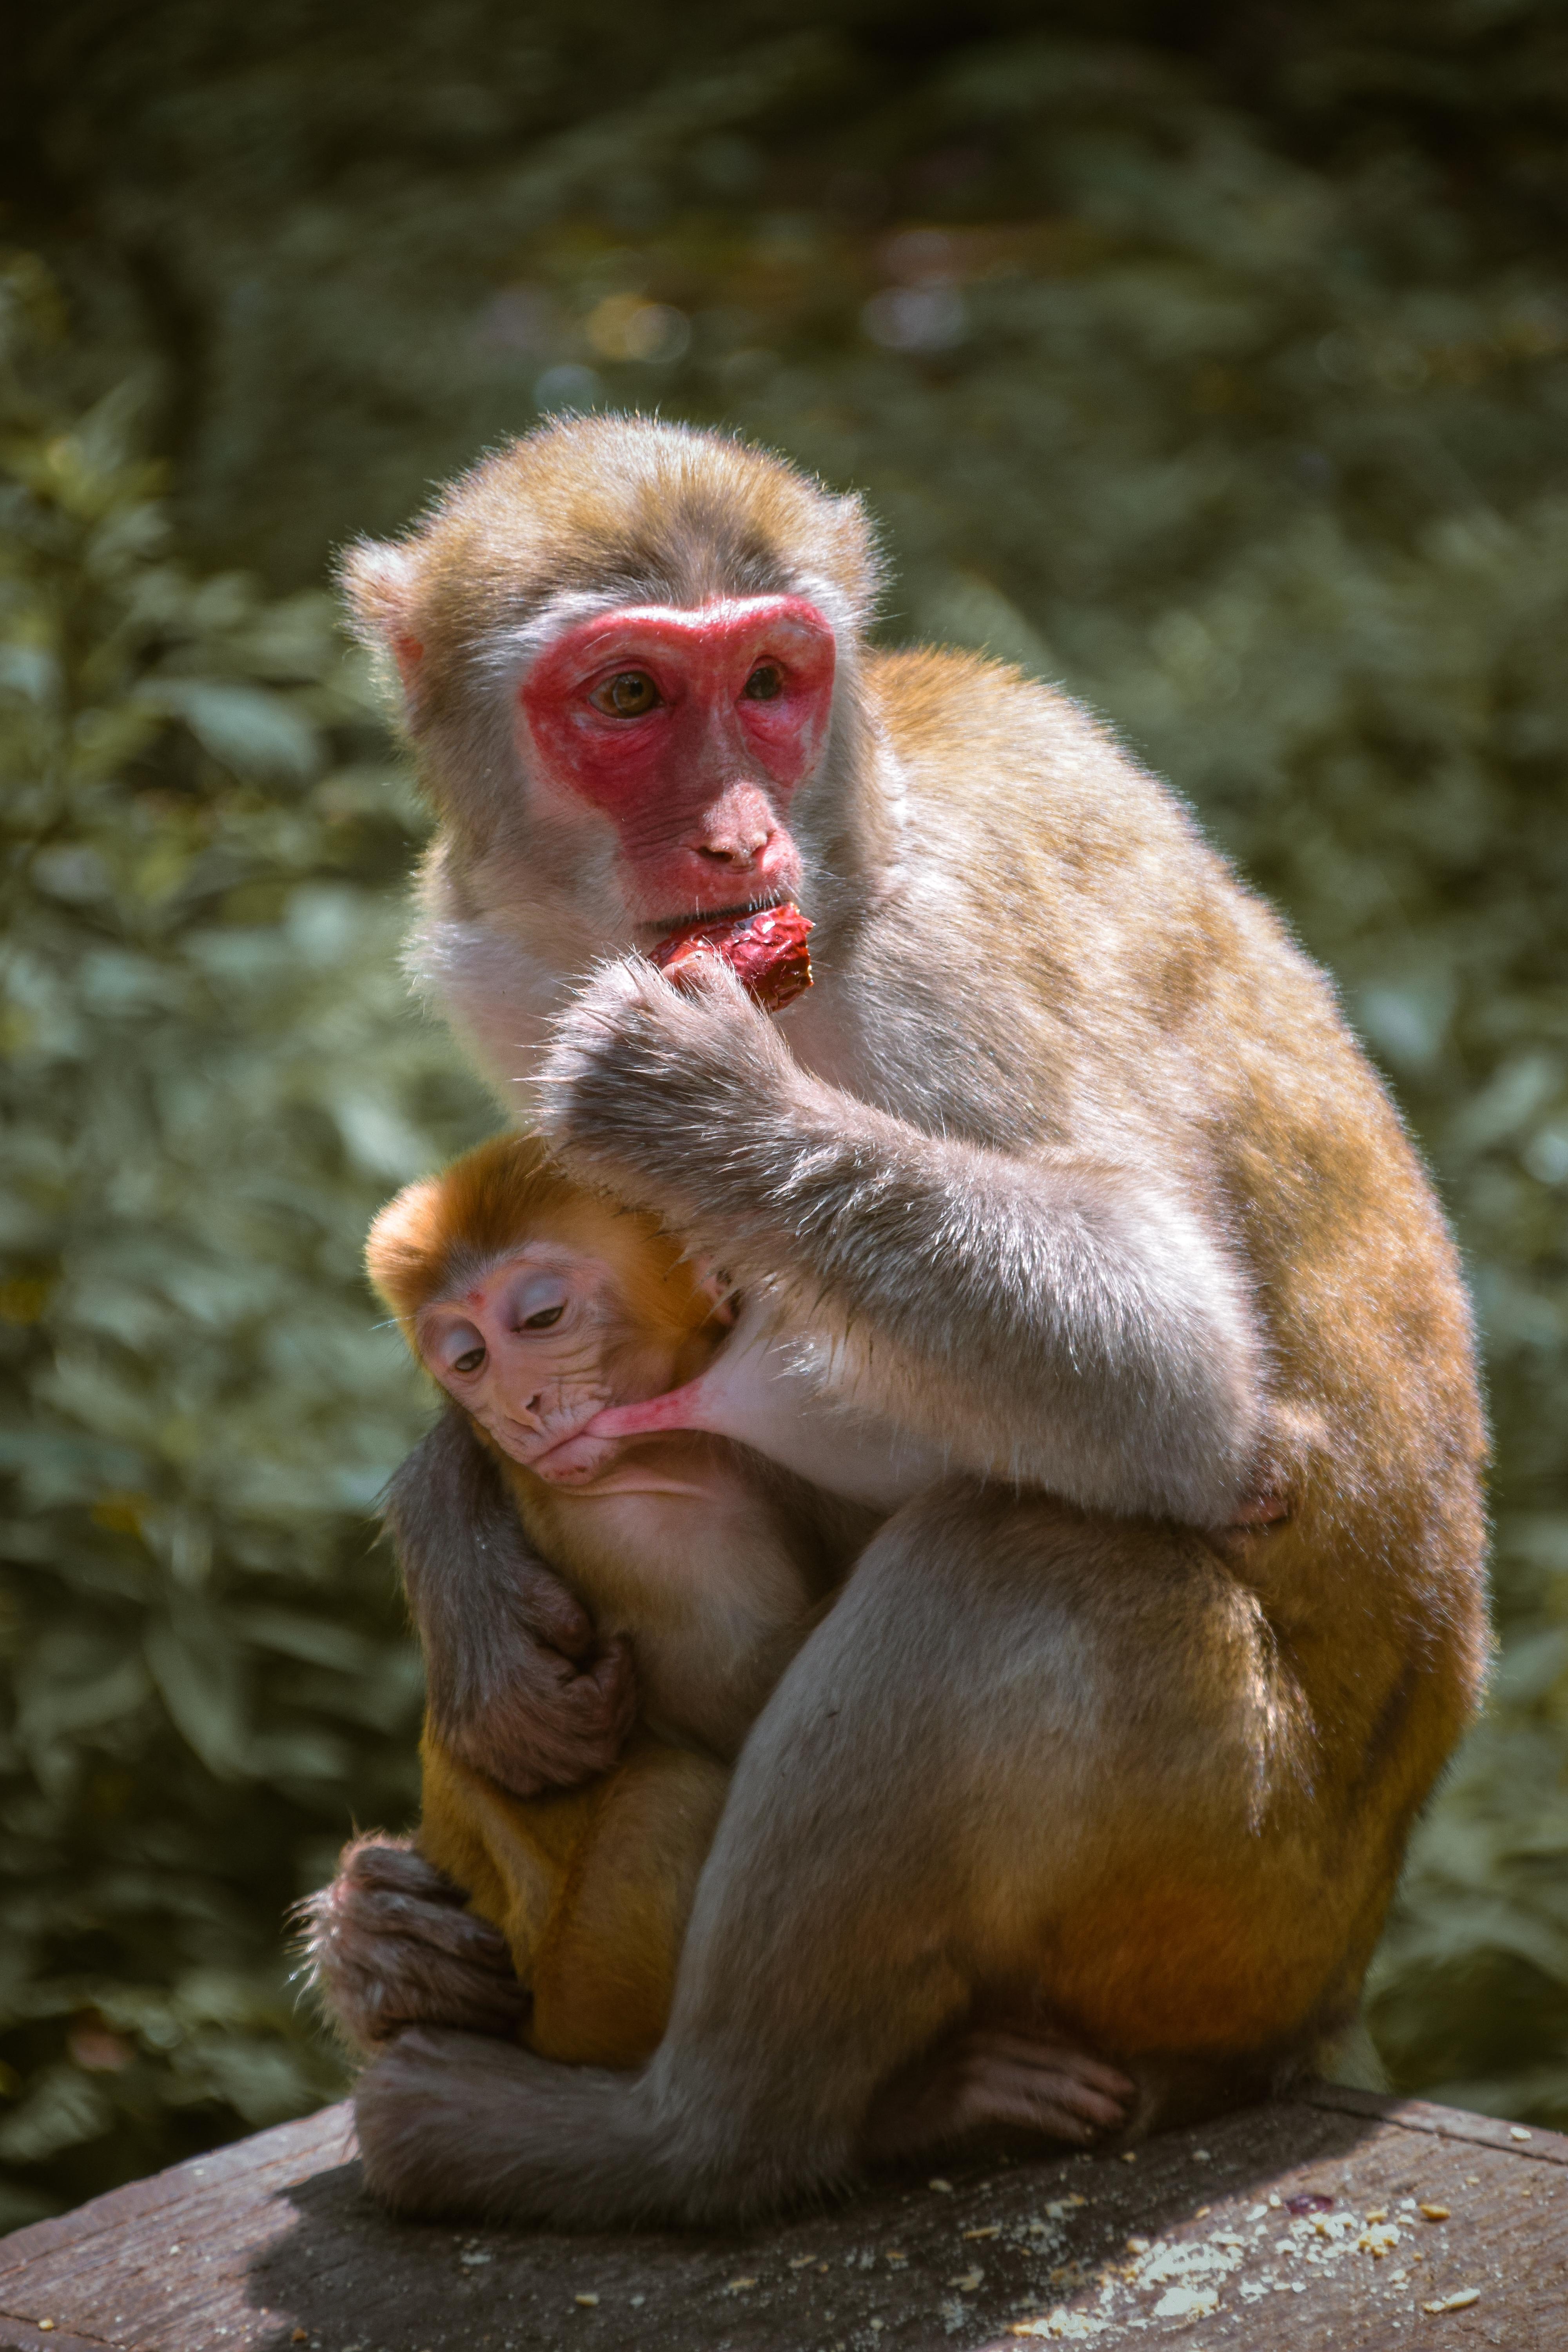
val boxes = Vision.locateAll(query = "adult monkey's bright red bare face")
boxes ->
[522,597,835,929]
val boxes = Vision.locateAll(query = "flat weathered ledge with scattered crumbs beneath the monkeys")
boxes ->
[0,2086,1568,2352]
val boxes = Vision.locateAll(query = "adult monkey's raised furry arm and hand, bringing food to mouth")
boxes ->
[541,960,1262,1526]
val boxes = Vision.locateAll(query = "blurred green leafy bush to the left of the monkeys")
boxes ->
[0,268,484,2220]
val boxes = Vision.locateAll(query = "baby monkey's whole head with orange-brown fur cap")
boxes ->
[365,1136,731,1484]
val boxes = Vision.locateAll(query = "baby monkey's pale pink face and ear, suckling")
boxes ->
[416,1240,724,1484]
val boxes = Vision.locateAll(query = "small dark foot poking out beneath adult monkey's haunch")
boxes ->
[860,2027,1138,2161]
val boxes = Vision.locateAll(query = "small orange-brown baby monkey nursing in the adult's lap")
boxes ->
[367,1134,869,2065]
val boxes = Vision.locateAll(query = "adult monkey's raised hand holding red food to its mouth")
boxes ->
[538,955,811,1256]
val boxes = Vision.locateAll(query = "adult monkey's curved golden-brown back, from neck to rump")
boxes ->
[823,654,1488,1872]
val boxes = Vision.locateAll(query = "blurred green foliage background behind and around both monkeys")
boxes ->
[0,0,1568,2223]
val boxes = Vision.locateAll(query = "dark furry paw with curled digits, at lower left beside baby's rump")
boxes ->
[296,1835,529,2051]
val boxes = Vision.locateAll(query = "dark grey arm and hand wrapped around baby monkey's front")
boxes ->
[383,1406,637,1797]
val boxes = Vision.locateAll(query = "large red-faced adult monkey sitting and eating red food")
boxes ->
[315,419,1486,2225]
